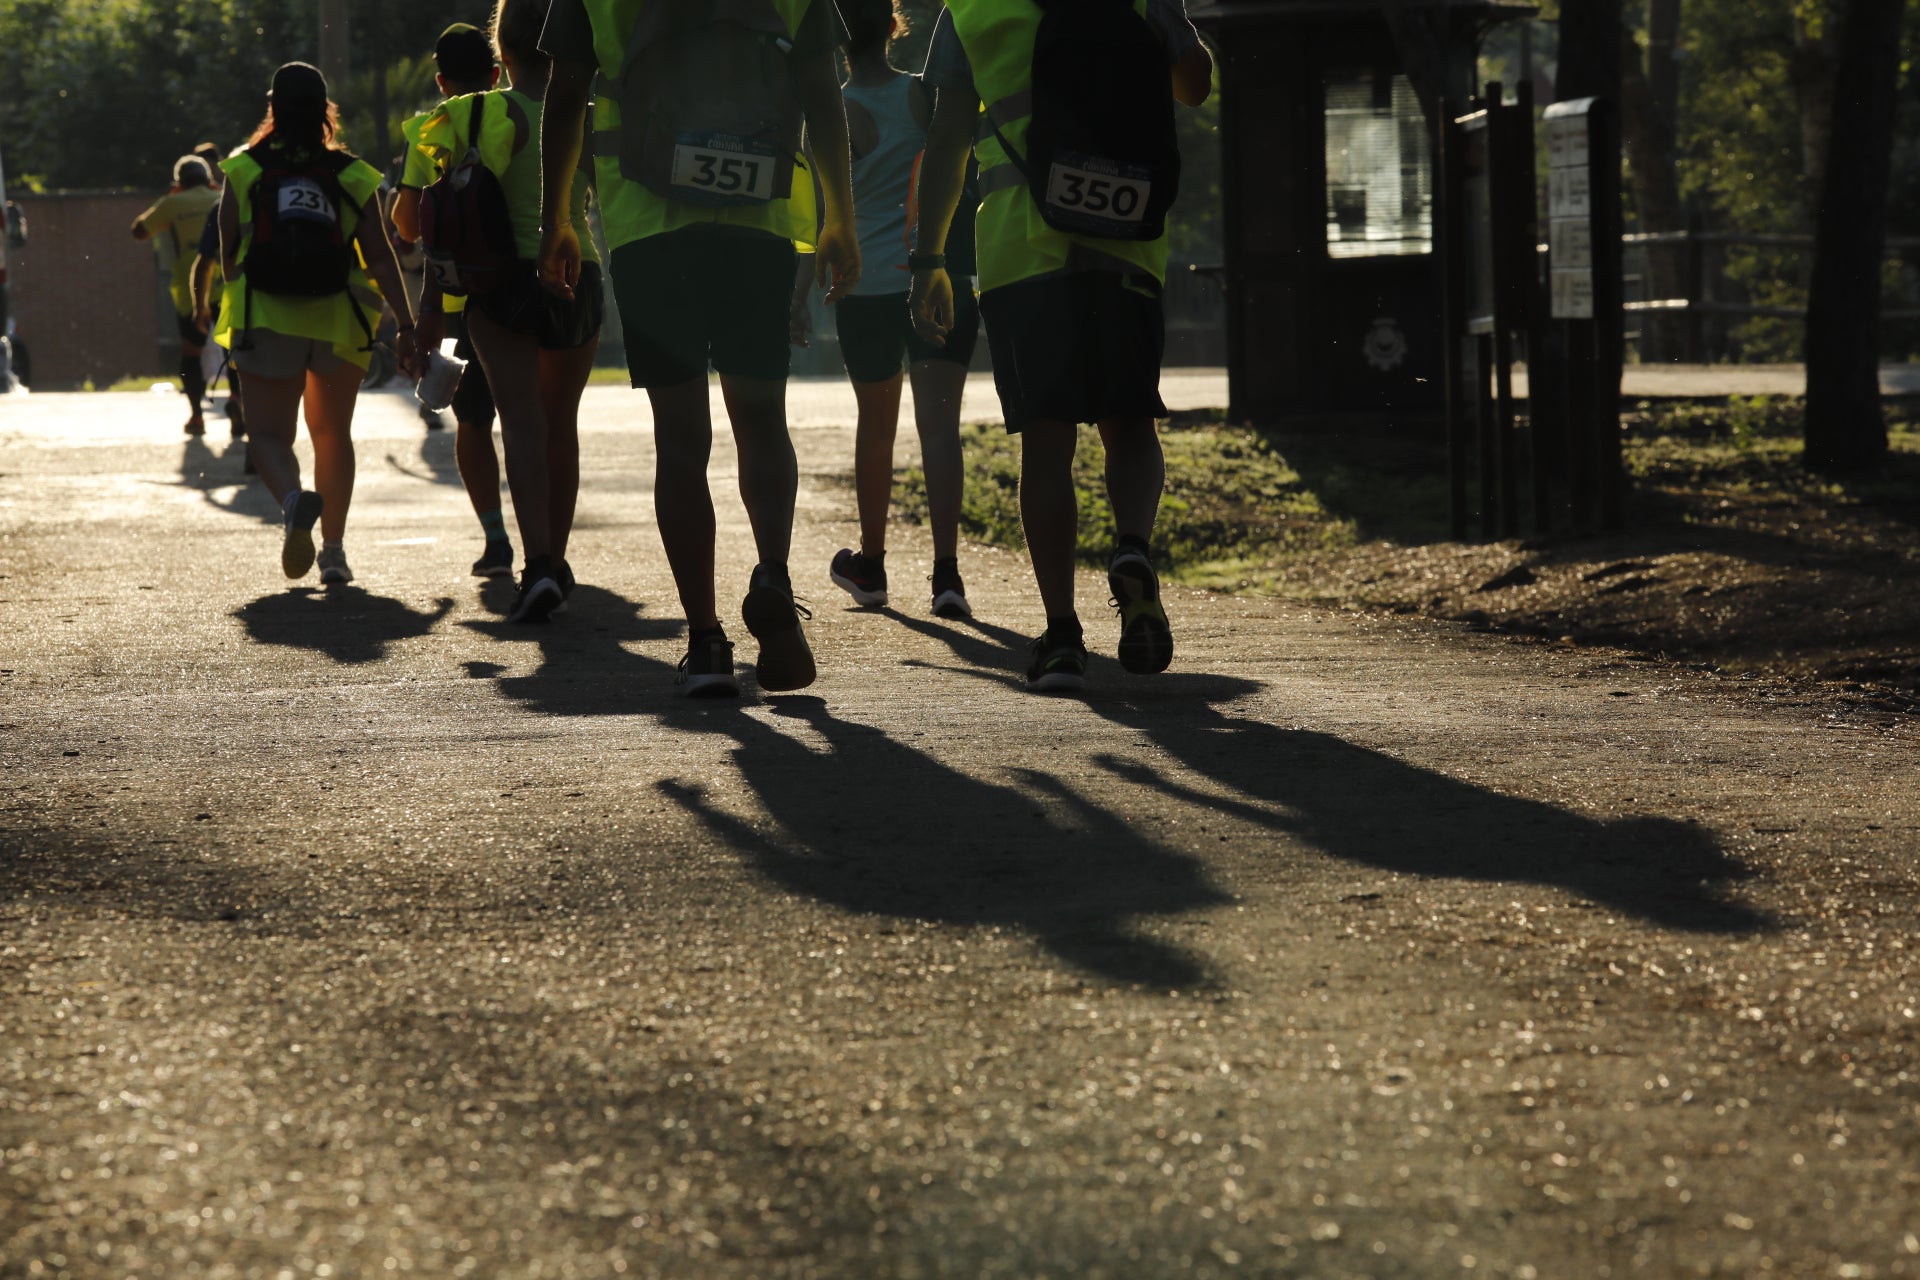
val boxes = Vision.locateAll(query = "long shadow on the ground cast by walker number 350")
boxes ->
[883,618,1772,933]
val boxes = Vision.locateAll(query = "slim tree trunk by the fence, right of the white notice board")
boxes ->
[1620,0,1699,363]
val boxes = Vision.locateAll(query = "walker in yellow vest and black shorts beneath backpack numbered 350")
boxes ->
[910,0,1213,693]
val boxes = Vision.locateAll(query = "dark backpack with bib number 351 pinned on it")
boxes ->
[612,0,798,207]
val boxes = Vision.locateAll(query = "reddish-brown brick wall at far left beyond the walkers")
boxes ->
[8,192,180,391]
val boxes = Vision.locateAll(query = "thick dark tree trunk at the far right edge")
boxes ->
[1805,0,1907,472]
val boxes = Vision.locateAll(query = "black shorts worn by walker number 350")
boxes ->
[979,271,1167,432]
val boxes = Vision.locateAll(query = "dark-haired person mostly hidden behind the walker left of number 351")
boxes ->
[394,23,513,578]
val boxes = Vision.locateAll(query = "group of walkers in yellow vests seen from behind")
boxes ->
[168,0,1212,697]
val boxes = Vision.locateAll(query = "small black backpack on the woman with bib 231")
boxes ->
[240,144,359,297]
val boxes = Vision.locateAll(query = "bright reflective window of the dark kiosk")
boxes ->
[1327,75,1434,257]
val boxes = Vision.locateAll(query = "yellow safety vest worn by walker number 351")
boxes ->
[584,0,816,249]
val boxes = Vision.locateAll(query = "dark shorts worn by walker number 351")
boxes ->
[609,223,793,388]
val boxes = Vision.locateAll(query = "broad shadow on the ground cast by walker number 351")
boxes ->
[657,697,1229,990]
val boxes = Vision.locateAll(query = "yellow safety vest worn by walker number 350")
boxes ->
[947,0,1167,290]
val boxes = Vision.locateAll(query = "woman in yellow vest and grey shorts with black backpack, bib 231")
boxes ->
[215,61,419,585]
